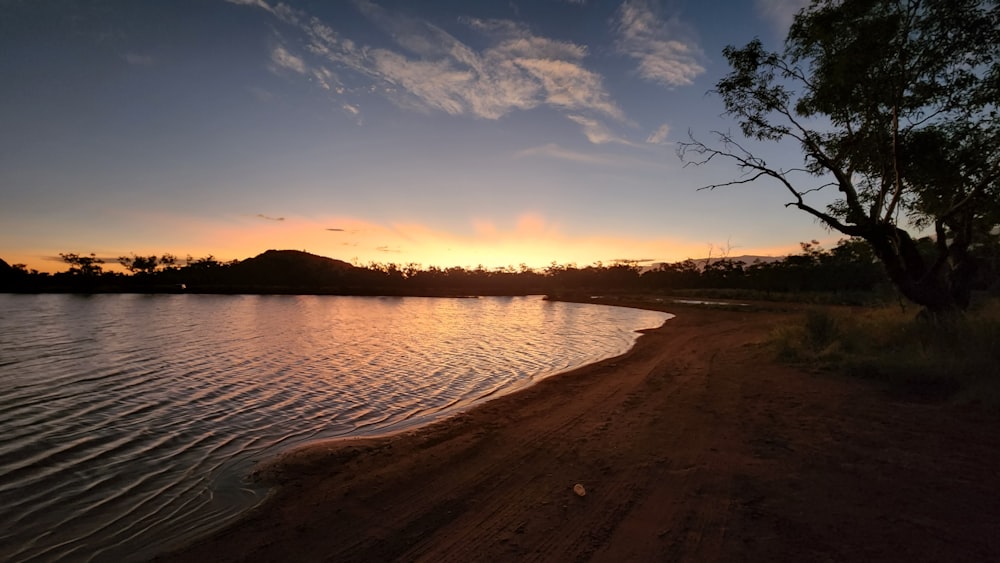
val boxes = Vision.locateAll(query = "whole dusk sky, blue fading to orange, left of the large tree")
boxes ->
[0,0,836,271]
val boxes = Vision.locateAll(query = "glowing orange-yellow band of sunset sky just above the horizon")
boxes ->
[0,212,837,273]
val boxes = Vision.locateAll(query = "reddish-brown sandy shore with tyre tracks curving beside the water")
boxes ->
[158,306,1000,562]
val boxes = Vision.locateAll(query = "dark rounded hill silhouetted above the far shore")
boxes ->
[227,250,357,288]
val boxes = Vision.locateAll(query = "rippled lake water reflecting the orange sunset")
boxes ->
[0,294,669,561]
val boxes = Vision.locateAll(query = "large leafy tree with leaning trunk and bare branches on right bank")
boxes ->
[678,0,1000,314]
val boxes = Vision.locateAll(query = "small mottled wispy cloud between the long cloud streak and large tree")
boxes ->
[615,0,705,87]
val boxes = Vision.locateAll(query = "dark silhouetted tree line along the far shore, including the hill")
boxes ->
[0,239,1000,297]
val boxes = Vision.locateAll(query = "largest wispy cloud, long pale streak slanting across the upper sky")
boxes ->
[229,0,626,129]
